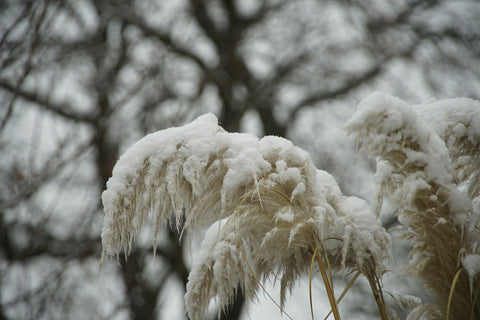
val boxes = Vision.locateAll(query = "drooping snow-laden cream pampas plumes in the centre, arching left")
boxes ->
[102,114,390,319]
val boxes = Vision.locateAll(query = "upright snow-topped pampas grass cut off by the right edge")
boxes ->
[346,92,480,319]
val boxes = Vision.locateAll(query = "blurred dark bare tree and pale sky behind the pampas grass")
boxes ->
[0,0,480,319]
